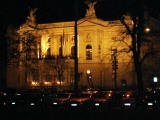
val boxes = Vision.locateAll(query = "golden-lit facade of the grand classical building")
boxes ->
[8,3,136,88]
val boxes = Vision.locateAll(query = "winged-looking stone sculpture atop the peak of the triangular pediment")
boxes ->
[86,1,96,17]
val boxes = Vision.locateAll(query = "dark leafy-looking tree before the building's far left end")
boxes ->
[6,27,37,87]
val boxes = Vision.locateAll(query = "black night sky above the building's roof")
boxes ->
[0,0,159,28]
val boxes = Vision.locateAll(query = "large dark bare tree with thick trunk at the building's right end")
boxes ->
[120,0,160,96]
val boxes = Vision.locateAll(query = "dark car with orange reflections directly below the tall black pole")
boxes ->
[67,92,93,110]
